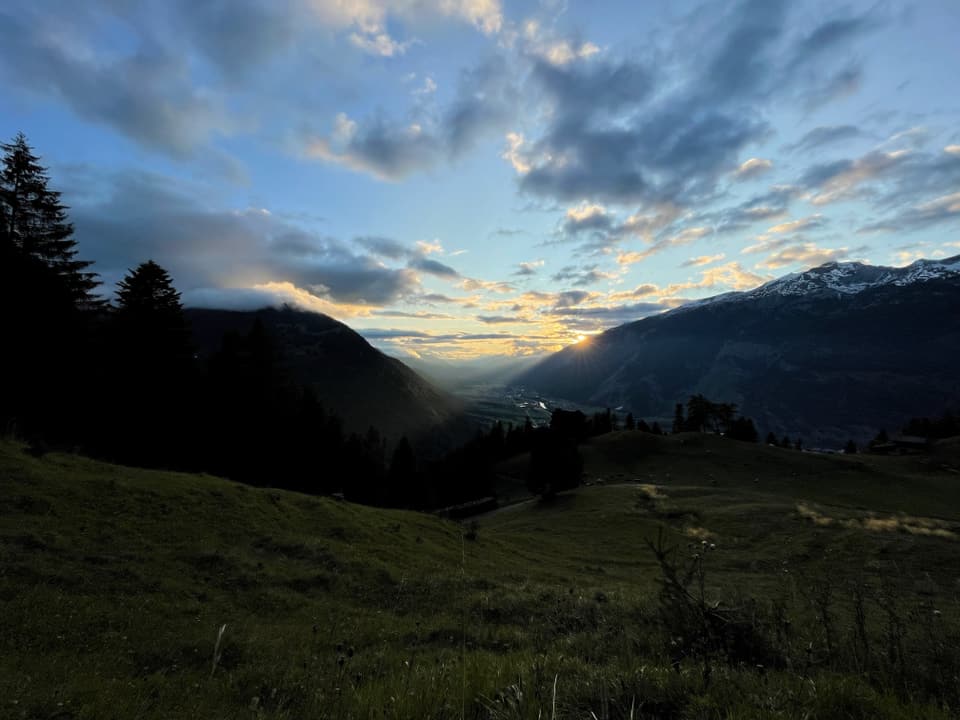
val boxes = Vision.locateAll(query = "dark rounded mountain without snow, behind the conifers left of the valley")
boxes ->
[186,307,460,440]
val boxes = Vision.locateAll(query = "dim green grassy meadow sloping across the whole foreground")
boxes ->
[0,433,960,719]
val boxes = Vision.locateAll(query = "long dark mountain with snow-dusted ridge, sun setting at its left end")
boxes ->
[517,256,960,445]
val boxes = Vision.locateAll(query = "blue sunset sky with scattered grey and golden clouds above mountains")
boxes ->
[0,0,960,361]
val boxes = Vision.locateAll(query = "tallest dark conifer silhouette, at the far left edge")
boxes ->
[0,133,98,442]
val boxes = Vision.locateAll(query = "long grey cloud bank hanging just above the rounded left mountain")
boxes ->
[64,172,428,306]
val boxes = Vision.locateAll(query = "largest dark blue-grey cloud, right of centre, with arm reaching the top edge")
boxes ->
[511,2,785,205]
